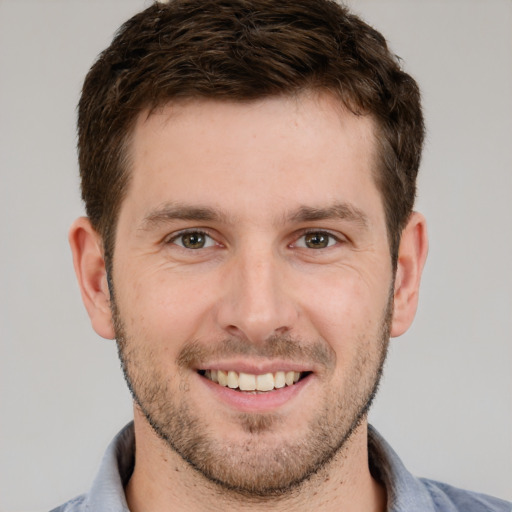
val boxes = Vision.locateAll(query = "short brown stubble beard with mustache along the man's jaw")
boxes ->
[112,295,393,500]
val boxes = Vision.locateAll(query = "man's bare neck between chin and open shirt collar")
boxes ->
[126,409,386,512]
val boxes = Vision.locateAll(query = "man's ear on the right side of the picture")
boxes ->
[391,212,428,337]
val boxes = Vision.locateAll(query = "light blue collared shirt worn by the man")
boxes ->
[51,423,512,512]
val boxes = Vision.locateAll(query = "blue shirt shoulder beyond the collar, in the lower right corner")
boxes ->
[420,478,512,512]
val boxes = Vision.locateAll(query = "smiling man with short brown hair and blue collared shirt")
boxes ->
[54,0,510,512]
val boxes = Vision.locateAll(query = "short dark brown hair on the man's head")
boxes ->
[78,0,424,266]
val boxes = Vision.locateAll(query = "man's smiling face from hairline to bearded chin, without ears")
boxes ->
[113,95,393,495]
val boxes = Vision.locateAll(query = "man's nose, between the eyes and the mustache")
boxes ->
[217,244,298,343]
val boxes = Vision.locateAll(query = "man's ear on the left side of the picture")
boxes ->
[69,217,115,339]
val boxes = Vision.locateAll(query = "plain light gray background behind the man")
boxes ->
[0,0,512,512]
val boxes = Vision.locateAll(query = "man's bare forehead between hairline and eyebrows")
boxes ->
[122,93,380,226]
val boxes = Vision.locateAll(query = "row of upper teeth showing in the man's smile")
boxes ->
[204,370,300,391]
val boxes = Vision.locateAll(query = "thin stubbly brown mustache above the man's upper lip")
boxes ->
[177,335,336,369]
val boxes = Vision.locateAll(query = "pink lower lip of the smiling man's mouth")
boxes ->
[198,374,313,412]
